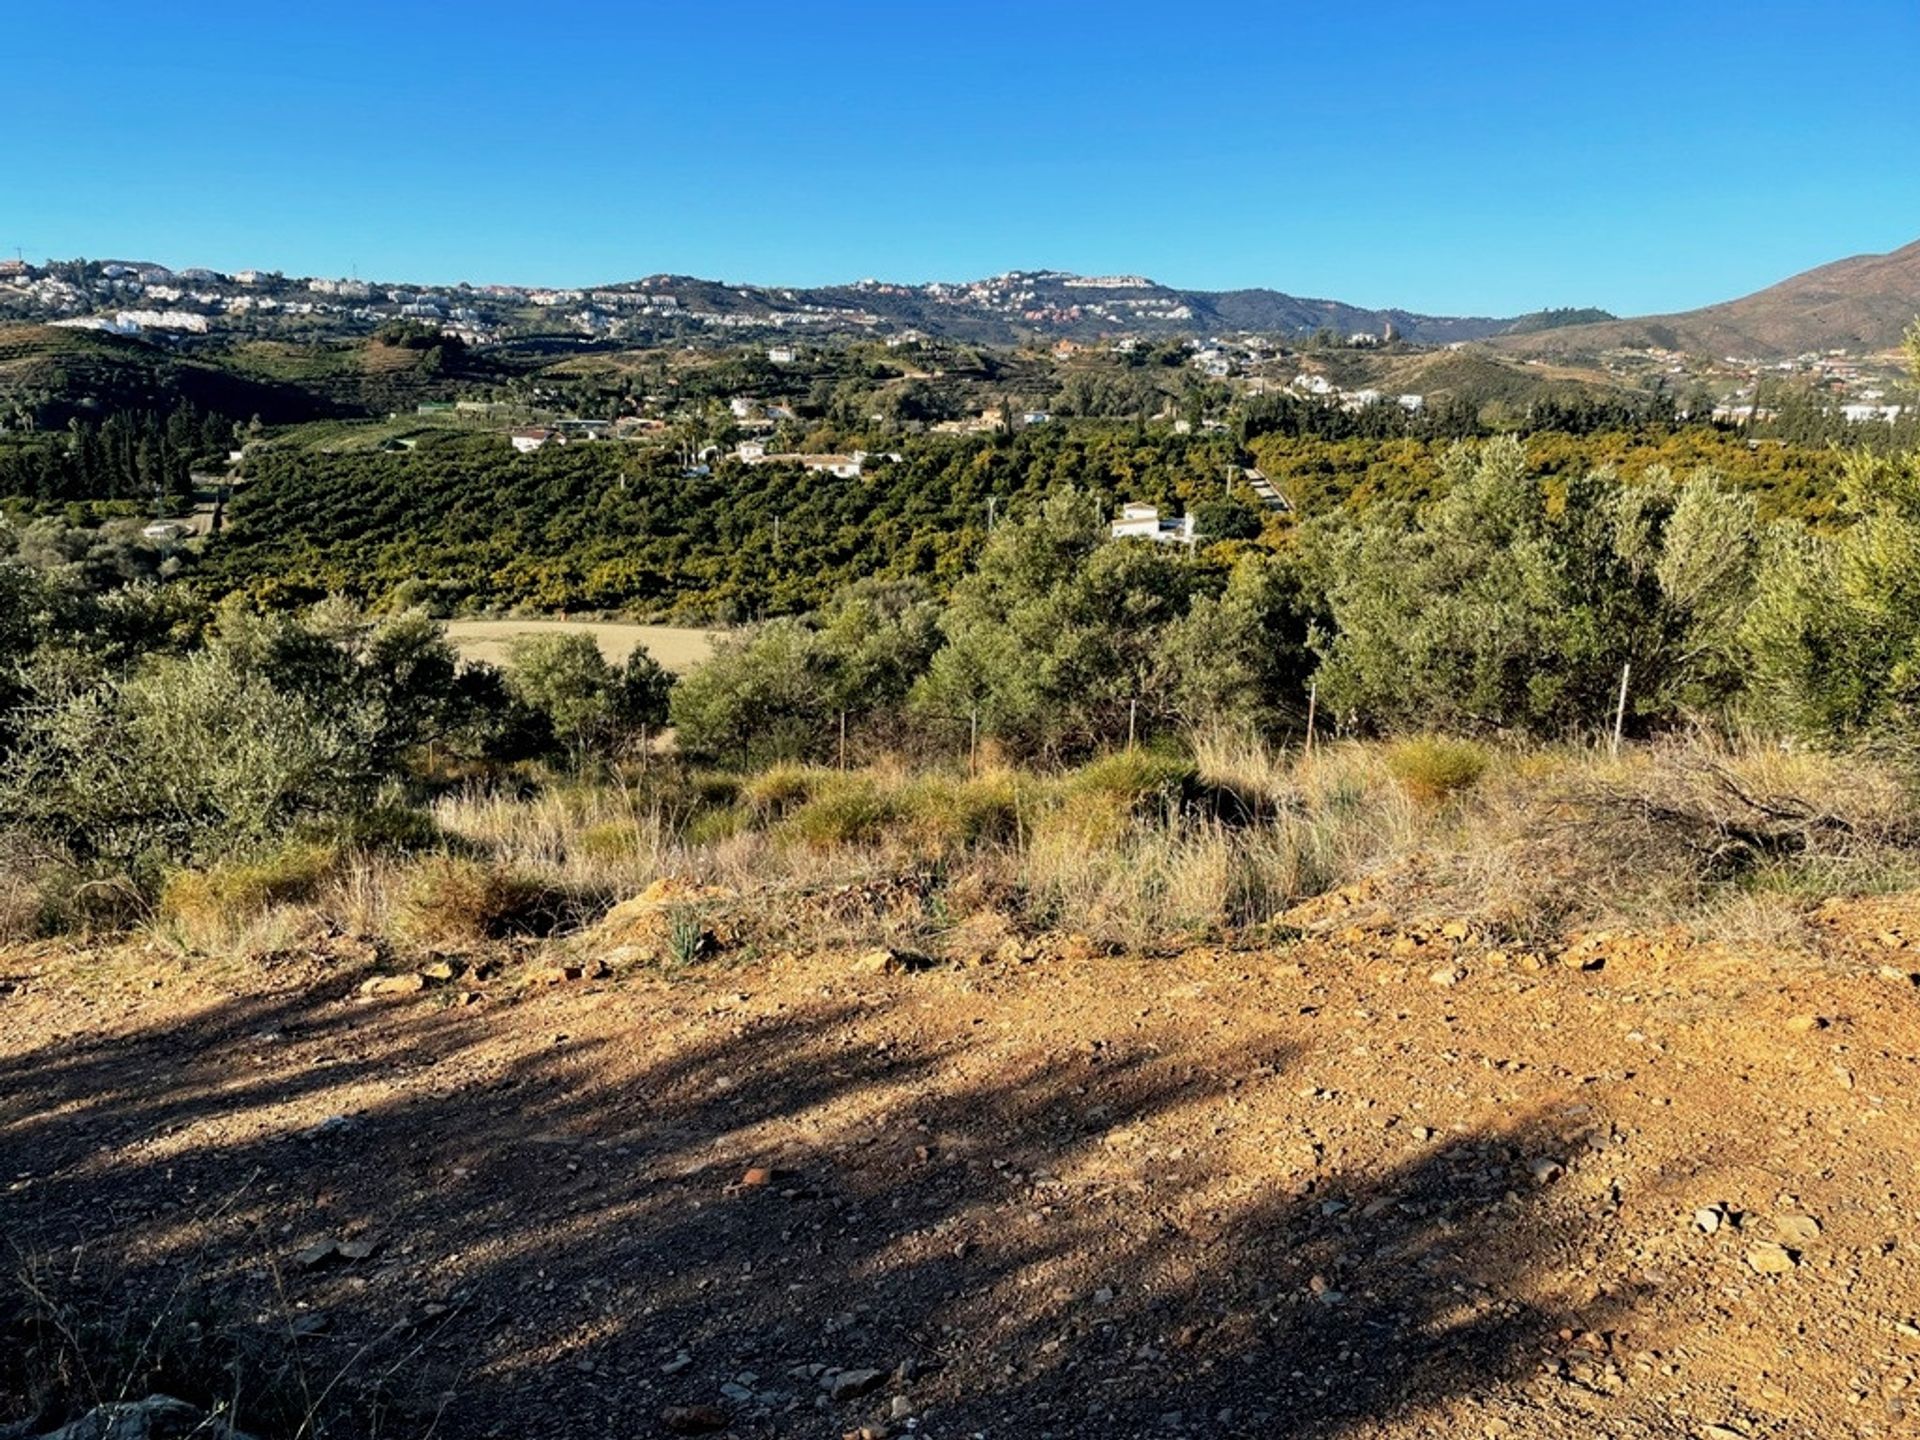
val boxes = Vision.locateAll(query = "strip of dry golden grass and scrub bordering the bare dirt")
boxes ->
[22,735,1920,971]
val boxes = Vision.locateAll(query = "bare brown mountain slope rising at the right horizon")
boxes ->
[1498,240,1920,359]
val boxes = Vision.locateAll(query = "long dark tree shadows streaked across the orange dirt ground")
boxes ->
[0,981,1626,1438]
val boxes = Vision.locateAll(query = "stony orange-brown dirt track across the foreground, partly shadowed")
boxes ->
[0,906,1920,1440]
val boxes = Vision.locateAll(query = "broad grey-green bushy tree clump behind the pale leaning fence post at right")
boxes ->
[1319,436,1757,735]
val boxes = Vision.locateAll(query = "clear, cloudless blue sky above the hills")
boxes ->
[0,0,1920,313]
